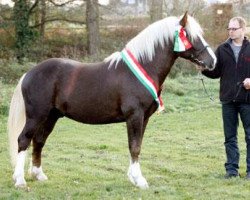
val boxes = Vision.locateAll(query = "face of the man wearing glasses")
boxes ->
[228,20,245,40]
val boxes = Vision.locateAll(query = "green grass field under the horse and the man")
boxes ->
[0,74,250,200]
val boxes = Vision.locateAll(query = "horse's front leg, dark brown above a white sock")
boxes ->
[127,115,148,189]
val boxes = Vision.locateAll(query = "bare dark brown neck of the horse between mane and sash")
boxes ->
[144,47,177,86]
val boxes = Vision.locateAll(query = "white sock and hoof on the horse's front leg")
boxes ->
[128,161,148,189]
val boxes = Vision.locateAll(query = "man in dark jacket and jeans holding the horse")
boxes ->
[202,17,250,180]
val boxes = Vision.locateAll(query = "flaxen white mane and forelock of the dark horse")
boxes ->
[104,16,203,66]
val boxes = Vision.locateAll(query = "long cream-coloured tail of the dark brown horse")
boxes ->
[8,74,26,167]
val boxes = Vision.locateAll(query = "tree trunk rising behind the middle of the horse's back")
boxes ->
[86,0,100,57]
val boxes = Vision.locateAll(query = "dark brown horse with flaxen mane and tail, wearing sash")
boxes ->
[8,12,216,189]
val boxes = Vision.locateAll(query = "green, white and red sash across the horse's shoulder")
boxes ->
[121,48,164,112]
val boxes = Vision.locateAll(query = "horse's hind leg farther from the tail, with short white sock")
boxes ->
[29,112,58,181]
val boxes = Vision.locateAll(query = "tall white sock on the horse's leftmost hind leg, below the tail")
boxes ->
[13,151,26,188]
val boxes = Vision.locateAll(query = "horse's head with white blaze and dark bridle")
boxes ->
[175,13,217,70]
